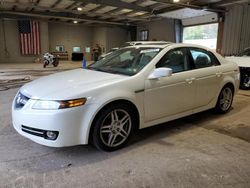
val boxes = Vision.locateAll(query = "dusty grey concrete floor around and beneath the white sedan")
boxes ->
[0,63,250,188]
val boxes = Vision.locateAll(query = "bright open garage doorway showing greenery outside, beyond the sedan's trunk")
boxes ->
[183,23,218,49]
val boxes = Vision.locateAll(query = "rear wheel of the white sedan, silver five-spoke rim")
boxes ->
[215,85,234,114]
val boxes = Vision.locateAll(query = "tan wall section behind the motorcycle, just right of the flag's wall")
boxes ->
[49,23,93,60]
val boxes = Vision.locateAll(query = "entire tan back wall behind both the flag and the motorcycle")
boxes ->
[0,20,131,63]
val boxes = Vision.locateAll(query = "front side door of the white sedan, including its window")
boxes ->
[144,48,195,122]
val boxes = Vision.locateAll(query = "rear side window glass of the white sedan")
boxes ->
[190,48,220,69]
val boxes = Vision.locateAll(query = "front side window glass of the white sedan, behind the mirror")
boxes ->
[156,48,191,73]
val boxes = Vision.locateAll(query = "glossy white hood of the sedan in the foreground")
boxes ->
[21,69,127,100]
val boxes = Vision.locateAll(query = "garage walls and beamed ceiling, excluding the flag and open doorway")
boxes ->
[0,1,250,63]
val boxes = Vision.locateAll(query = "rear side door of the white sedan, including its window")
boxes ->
[190,48,223,108]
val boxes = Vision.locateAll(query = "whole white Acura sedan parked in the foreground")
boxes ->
[12,43,240,151]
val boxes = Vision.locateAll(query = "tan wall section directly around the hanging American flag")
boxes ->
[0,20,48,63]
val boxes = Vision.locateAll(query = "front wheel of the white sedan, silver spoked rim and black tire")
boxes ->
[92,103,136,151]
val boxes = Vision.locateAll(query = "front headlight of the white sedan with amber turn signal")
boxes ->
[32,98,87,110]
